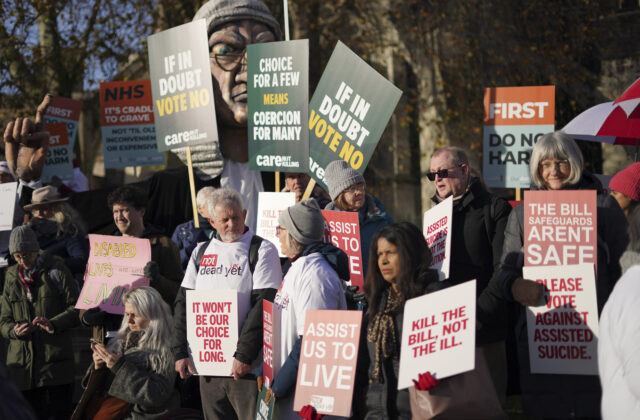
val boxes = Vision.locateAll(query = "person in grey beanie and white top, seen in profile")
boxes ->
[267,199,349,419]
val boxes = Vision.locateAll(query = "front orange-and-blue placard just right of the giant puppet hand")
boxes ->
[40,123,73,183]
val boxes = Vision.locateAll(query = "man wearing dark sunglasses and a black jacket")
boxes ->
[427,147,511,402]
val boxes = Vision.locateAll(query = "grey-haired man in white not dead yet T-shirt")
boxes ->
[173,188,282,419]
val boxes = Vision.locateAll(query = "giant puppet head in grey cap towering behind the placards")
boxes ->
[175,0,281,230]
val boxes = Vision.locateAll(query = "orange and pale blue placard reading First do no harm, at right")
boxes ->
[482,86,555,188]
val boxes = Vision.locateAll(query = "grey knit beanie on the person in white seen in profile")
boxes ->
[278,198,324,245]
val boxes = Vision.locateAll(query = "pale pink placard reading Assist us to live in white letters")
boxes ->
[293,310,363,417]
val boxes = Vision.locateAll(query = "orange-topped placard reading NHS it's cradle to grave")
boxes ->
[100,80,165,168]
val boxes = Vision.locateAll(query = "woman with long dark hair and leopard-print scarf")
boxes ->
[356,222,443,419]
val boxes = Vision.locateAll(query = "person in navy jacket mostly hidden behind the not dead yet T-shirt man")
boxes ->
[171,187,216,270]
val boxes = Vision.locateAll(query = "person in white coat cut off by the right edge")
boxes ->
[598,207,640,420]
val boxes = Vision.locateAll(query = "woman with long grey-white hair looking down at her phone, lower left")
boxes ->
[72,287,178,419]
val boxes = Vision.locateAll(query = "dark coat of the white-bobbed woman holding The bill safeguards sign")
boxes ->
[497,171,628,418]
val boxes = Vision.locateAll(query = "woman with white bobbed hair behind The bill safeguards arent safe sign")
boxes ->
[497,131,627,418]
